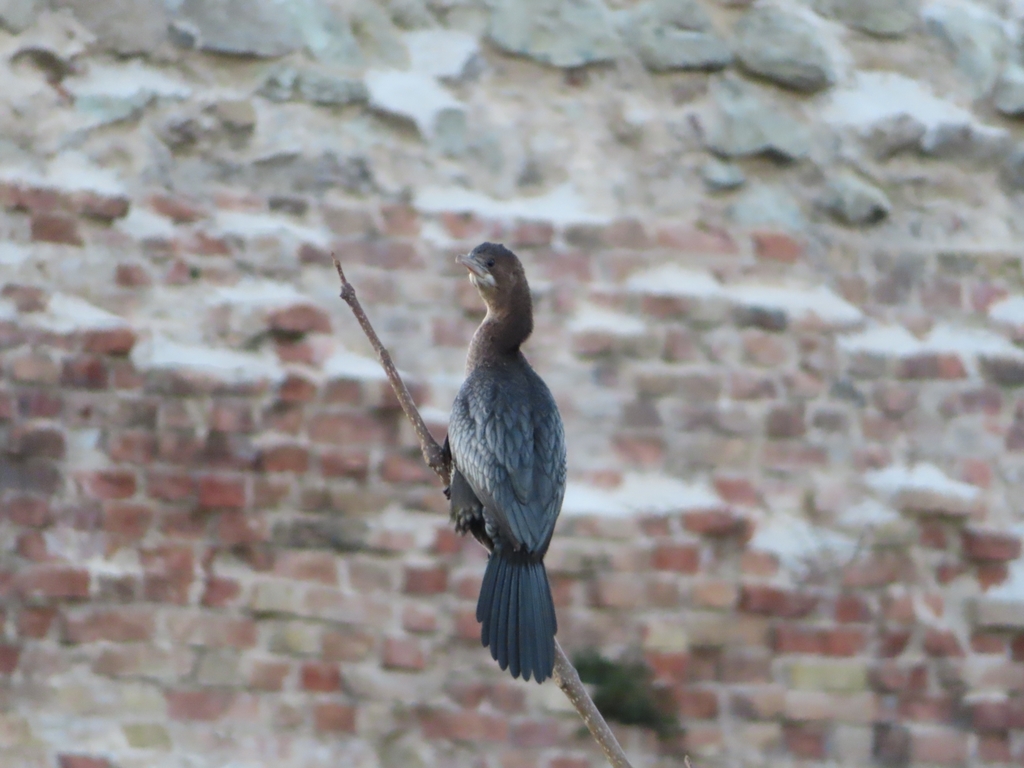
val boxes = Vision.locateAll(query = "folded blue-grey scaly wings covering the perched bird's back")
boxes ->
[449,377,565,552]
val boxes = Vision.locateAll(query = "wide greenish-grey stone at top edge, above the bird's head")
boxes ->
[487,0,622,67]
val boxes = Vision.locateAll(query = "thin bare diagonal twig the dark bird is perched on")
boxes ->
[334,258,632,768]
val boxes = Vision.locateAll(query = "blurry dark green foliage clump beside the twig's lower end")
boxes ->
[572,650,679,738]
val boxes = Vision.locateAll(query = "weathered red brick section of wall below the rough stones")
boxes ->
[0,182,1024,768]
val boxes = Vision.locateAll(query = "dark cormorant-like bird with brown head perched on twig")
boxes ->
[443,243,566,683]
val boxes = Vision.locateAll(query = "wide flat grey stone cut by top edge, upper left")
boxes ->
[171,0,304,58]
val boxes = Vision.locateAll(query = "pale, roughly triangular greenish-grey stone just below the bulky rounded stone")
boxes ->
[705,77,810,160]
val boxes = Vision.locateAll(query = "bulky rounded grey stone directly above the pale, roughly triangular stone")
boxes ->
[735,5,838,91]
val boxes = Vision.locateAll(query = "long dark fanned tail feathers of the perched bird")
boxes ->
[476,550,558,683]
